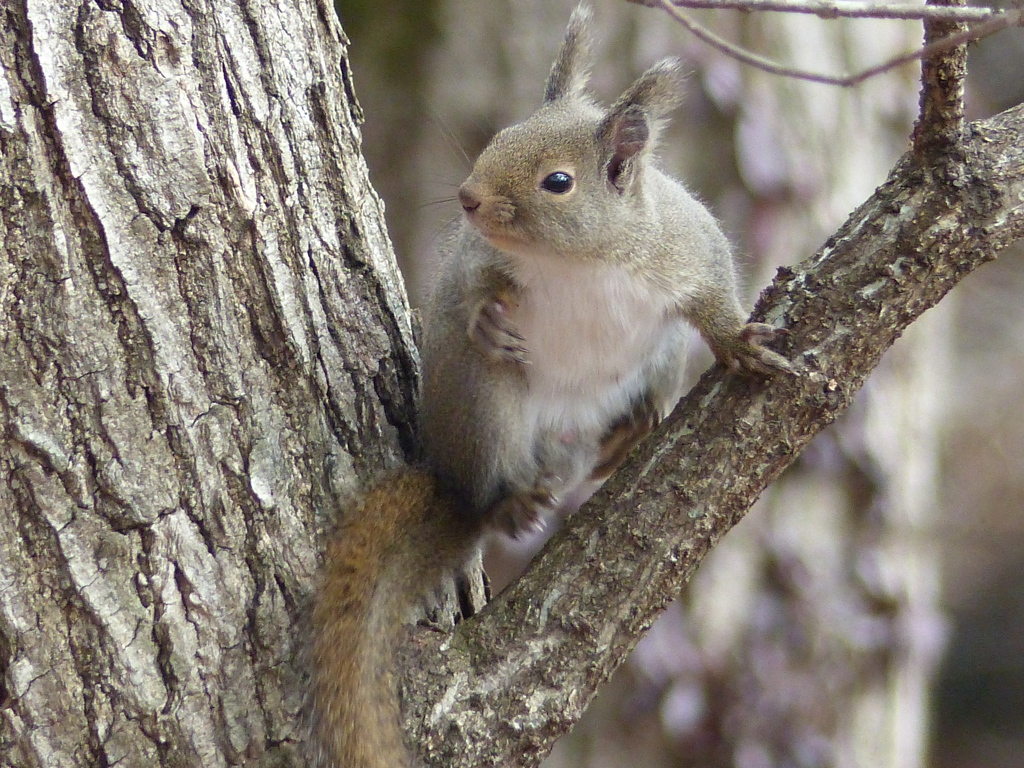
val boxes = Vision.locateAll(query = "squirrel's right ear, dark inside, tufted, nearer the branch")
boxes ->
[597,58,682,191]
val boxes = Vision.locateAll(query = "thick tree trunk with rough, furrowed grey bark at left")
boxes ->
[0,0,416,768]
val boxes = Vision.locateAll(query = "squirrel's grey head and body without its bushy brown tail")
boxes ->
[421,6,790,535]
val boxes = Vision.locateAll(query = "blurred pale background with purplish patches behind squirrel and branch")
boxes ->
[331,0,1024,768]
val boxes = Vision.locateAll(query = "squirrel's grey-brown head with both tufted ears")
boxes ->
[459,5,682,257]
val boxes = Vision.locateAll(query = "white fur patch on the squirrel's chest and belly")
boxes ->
[513,255,686,442]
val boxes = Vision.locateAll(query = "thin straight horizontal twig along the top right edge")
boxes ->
[628,0,999,22]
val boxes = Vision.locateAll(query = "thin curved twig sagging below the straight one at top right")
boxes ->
[651,0,1024,88]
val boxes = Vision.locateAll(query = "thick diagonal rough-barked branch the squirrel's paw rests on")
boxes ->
[407,106,1024,766]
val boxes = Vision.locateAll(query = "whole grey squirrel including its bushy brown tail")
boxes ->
[309,5,793,768]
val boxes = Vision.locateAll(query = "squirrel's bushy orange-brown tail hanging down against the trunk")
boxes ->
[309,470,478,768]
